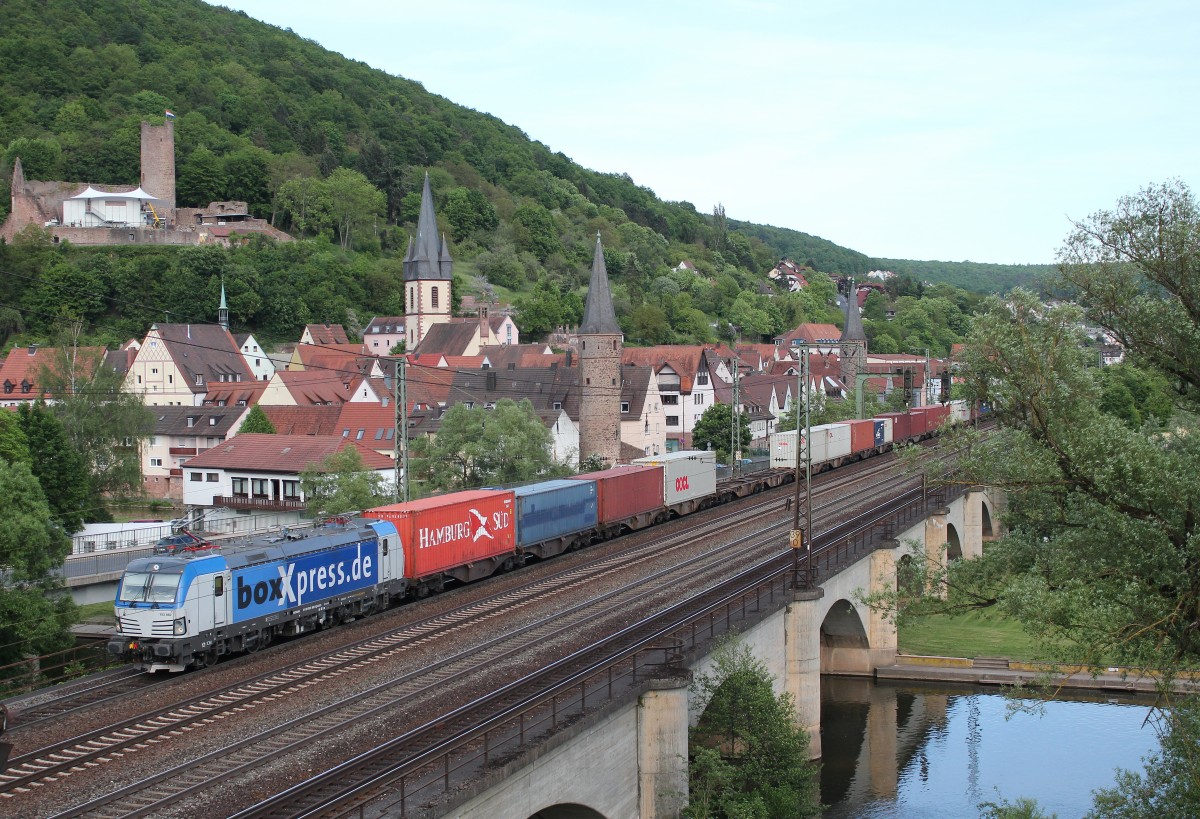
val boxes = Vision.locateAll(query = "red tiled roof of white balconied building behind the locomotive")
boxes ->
[180,432,392,474]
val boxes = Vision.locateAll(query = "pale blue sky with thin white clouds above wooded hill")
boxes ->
[206,0,1200,264]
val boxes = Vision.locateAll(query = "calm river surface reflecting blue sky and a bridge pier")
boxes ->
[821,676,1157,819]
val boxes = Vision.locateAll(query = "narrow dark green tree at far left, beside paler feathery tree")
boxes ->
[17,402,91,534]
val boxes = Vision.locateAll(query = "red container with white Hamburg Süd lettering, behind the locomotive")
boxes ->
[362,489,516,580]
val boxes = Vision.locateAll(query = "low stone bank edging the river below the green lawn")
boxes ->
[875,654,1200,694]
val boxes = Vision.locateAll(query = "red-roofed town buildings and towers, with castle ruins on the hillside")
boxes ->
[0,134,947,537]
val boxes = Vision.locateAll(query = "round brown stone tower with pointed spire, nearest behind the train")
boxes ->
[580,233,625,465]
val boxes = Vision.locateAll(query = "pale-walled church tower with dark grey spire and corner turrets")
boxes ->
[404,174,454,353]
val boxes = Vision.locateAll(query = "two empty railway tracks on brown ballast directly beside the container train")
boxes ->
[0,444,955,817]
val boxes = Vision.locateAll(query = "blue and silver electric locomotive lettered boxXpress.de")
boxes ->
[108,520,407,671]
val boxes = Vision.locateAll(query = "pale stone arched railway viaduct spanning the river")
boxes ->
[442,488,1003,819]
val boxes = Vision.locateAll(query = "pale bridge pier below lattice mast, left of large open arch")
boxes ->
[784,587,824,759]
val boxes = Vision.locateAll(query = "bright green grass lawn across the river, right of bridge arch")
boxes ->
[899,609,1045,660]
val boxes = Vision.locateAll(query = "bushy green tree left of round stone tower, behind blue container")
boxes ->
[410,399,568,489]
